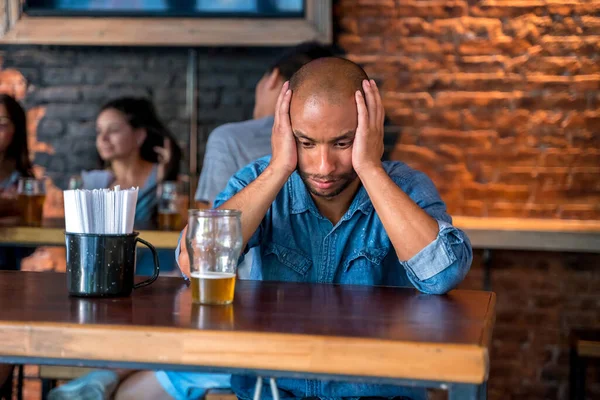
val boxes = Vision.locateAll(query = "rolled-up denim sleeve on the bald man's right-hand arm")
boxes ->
[394,172,473,294]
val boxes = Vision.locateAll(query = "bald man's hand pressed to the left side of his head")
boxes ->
[271,82,298,176]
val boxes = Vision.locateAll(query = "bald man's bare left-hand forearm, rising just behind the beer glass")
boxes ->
[219,165,289,247]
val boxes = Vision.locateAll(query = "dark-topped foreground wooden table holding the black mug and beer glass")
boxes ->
[0,271,495,400]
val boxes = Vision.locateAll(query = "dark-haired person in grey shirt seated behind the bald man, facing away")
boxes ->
[195,42,333,279]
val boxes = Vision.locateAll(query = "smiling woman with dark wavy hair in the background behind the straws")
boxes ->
[81,97,181,222]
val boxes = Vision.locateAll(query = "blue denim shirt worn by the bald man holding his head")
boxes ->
[209,156,472,399]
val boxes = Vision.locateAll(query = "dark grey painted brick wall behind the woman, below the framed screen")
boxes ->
[0,46,281,187]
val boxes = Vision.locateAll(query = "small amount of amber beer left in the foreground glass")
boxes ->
[191,272,235,304]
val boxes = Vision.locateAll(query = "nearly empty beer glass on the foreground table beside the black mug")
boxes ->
[185,210,243,304]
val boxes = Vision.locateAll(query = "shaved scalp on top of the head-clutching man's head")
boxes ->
[290,57,369,104]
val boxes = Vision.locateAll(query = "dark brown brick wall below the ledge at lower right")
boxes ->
[460,251,600,400]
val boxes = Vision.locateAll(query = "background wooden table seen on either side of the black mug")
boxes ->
[0,219,180,249]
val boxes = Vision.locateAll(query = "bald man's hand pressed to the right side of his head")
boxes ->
[352,79,385,176]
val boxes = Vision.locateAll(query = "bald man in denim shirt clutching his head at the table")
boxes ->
[117,58,472,400]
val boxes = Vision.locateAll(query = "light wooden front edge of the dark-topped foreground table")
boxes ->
[0,321,489,384]
